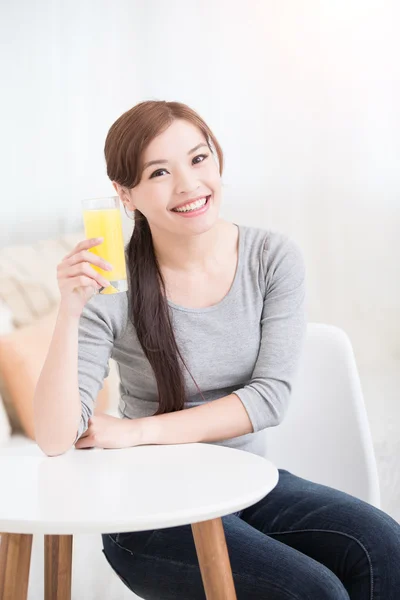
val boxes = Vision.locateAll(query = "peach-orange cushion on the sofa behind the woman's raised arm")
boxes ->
[0,307,108,439]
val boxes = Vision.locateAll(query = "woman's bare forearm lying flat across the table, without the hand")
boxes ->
[138,394,253,444]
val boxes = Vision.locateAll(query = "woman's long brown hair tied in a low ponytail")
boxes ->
[104,100,223,414]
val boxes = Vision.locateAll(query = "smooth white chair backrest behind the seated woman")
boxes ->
[266,323,380,507]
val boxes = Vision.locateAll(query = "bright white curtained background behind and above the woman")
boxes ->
[0,0,400,368]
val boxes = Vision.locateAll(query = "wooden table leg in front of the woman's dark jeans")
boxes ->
[192,518,236,600]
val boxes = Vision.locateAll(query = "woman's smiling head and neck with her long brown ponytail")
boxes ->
[105,101,227,414]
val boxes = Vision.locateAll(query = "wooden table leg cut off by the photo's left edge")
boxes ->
[0,533,32,600]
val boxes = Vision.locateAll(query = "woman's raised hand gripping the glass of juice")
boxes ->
[57,238,112,317]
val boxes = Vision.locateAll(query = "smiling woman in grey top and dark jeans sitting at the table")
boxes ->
[36,101,400,600]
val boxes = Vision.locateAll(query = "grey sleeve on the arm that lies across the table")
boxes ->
[233,236,307,432]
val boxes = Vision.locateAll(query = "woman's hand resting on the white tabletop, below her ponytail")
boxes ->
[75,413,142,449]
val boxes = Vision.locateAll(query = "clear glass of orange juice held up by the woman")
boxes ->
[82,196,128,294]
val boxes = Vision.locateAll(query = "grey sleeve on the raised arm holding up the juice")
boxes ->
[74,294,114,444]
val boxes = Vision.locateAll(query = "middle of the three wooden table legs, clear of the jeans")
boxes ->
[44,535,72,600]
